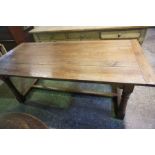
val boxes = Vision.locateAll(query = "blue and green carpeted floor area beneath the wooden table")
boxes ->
[0,79,123,128]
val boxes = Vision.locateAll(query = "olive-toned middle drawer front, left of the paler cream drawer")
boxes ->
[68,31,99,40]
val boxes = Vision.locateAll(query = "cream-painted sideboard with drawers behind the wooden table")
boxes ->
[30,26,147,44]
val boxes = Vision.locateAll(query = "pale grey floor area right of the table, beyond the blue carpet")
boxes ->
[124,29,155,128]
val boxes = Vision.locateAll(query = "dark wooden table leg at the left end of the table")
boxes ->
[0,76,25,103]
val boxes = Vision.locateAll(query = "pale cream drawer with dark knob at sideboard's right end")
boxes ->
[101,31,140,39]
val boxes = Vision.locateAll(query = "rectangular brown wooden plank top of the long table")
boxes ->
[0,39,155,85]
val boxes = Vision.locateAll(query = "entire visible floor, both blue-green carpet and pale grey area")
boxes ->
[0,29,155,129]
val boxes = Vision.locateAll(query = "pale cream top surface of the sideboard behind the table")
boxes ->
[30,26,146,33]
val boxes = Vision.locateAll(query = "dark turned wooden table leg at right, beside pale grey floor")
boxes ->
[116,85,134,119]
